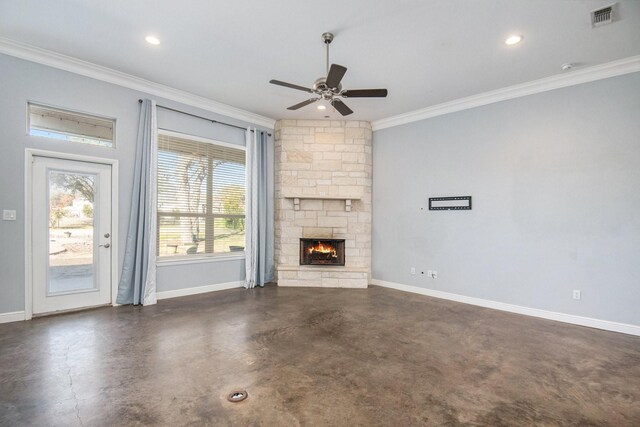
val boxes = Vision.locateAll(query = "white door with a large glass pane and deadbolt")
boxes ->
[32,156,112,314]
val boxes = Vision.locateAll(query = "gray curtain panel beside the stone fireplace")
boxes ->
[245,129,273,288]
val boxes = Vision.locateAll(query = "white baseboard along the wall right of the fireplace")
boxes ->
[371,279,640,336]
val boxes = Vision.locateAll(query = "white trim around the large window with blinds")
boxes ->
[155,128,247,267]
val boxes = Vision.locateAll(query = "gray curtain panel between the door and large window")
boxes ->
[116,99,158,305]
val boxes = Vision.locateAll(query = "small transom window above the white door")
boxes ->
[27,103,115,148]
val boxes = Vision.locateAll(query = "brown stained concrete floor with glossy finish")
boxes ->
[0,287,640,427]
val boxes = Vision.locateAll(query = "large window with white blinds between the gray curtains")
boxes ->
[157,131,245,257]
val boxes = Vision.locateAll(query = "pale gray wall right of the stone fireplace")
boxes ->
[372,73,640,325]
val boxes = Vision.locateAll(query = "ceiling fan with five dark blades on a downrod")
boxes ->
[269,33,387,116]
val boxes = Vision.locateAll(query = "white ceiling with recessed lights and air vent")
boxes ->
[0,0,640,120]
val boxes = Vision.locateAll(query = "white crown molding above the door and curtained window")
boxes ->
[0,37,275,129]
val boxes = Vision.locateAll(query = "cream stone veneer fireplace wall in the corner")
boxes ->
[274,120,372,288]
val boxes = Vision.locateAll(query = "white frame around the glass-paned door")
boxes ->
[24,148,120,320]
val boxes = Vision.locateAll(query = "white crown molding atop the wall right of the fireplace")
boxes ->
[371,55,640,131]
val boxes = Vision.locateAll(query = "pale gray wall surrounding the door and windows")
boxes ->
[0,54,272,313]
